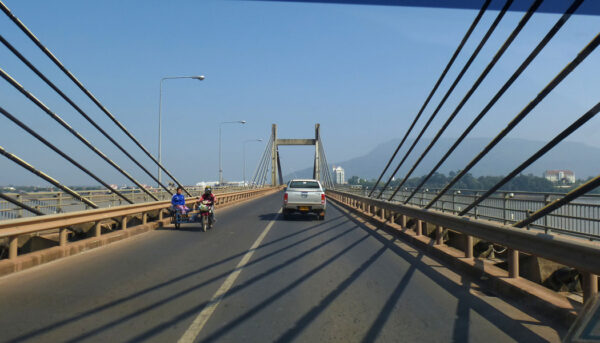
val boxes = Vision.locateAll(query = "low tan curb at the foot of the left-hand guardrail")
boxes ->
[0,189,279,277]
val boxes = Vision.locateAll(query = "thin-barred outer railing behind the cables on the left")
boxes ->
[0,186,252,220]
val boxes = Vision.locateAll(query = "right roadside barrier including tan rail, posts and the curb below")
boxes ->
[327,190,600,309]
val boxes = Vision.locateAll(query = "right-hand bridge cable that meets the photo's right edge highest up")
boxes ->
[425,34,600,209]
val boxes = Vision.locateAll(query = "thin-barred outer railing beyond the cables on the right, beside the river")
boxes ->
[336,187,600,240]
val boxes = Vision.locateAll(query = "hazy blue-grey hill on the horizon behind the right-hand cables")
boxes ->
[284,138,600,180]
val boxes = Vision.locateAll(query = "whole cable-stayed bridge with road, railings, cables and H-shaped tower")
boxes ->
[0,0,600,342]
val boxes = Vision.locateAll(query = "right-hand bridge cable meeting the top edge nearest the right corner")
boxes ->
[404,0,583,204]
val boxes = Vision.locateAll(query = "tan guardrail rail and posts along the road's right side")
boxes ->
[327,190,600,299]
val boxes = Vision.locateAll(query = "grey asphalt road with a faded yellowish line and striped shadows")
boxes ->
[0,193,564,343]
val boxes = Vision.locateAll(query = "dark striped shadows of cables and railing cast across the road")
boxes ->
[10,202,556,342]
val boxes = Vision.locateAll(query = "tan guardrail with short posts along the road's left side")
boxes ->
[0,187,278,260]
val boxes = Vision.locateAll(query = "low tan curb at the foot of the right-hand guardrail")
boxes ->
[329,198,581,325]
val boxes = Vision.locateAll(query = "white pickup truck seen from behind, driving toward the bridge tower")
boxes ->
[283,179,327,220]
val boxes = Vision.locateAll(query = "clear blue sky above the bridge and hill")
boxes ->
[0,0,600,184]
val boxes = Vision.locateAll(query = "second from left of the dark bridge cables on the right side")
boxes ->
[377,0,513,198]
